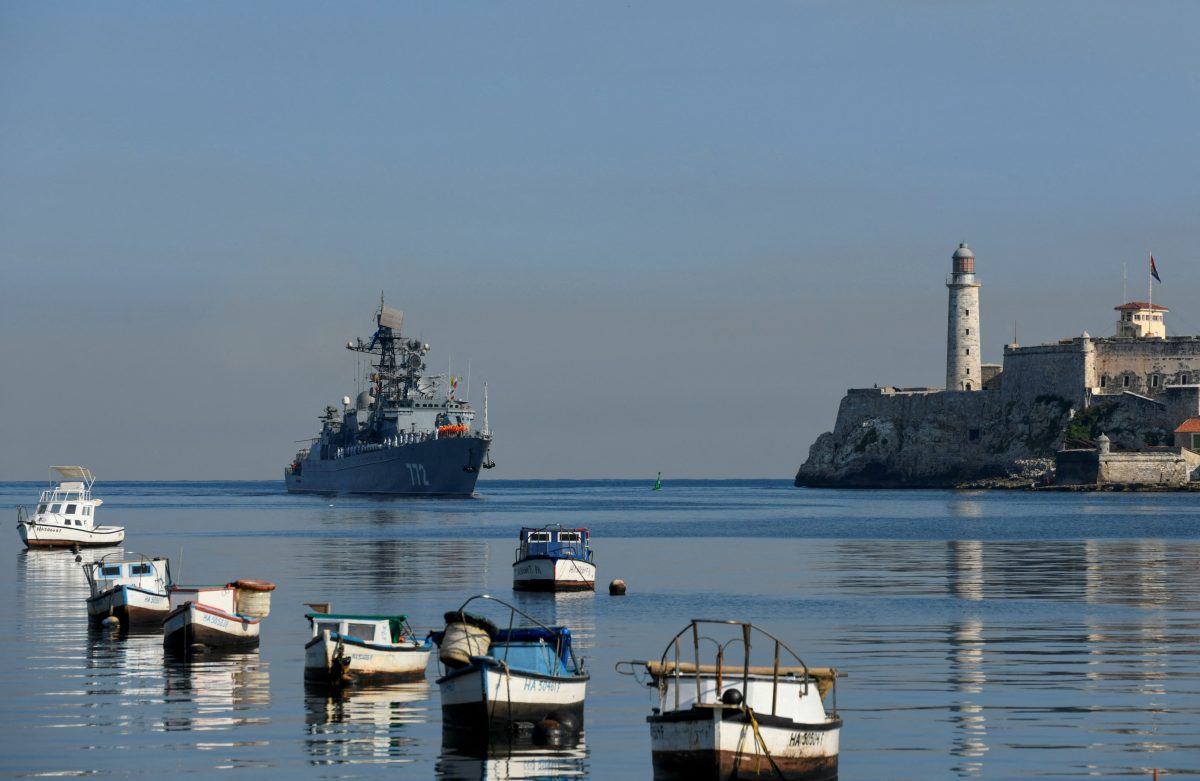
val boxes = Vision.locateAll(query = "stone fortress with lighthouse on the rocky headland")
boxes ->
[796,244,1200,487]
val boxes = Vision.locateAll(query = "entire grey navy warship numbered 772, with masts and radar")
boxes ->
[283,298,496,497]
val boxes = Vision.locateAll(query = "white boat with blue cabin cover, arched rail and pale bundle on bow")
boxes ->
[432,594,589,732]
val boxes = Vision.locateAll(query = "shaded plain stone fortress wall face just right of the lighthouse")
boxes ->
[1001,338,1092,408]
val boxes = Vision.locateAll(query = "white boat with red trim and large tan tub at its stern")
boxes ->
[162,581,275,651]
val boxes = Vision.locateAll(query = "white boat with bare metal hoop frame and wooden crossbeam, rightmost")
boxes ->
[617,619,845,781]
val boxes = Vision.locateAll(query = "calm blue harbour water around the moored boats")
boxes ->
[0,481,1200,781]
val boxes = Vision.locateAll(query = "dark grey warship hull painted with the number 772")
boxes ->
[283,437,491,497]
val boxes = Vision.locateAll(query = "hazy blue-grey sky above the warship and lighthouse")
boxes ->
[0,0,1200,481]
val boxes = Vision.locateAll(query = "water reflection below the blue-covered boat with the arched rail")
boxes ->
[437,732,588,781]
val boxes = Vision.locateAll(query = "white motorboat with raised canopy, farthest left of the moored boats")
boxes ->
[17,467,125,548]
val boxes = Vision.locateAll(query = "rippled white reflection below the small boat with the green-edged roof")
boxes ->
[304,680,430,765]
